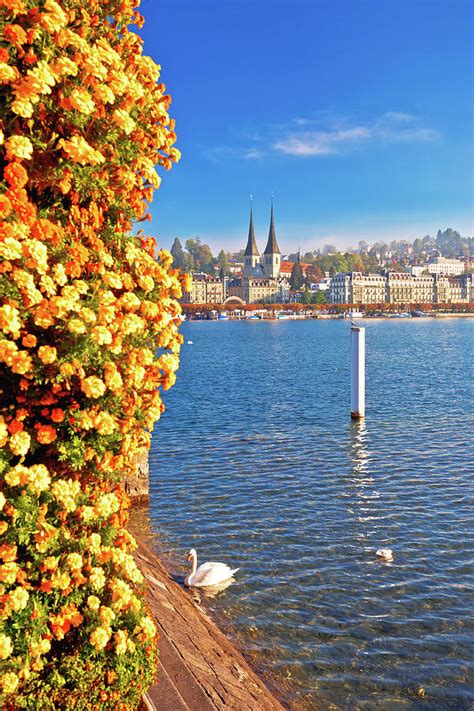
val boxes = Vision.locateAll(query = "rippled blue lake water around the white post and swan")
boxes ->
[150,318,474,711]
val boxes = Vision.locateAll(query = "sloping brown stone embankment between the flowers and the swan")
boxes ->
[130,509,285,711]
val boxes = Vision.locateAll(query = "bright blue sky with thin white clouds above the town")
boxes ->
[141,0,474,252]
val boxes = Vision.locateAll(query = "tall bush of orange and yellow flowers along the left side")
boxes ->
[0,0,189,709]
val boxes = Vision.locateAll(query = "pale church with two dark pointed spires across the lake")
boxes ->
[227,200,290,304]
